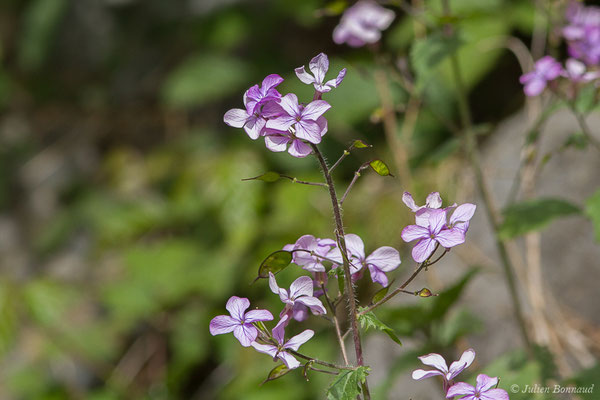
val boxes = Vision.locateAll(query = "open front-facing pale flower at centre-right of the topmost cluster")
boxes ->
[267,93,331,144]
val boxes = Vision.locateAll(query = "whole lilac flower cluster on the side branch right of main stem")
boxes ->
[401,192,476,263]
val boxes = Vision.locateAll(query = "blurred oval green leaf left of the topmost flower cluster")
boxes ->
[162,54,248,108]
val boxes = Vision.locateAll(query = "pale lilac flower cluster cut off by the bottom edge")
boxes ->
[412,349,509,400]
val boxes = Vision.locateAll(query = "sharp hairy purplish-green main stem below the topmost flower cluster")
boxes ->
[311,143,371,400]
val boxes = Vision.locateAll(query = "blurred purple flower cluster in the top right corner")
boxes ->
[519,2,600,96]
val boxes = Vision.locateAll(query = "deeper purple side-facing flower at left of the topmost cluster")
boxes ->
[223,74,283,140]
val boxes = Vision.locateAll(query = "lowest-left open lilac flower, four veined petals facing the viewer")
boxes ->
[209,296,273,347]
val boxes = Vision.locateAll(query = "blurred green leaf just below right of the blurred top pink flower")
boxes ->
[410,32,463,88]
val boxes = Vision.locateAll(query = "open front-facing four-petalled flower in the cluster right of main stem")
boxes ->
[401,209,474,263]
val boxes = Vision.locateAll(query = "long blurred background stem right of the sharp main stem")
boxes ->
[442,0,531,352]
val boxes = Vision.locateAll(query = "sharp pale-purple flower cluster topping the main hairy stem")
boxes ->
[223,53,346,158]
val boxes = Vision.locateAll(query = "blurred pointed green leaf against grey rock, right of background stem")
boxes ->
[499,199,581,239]
